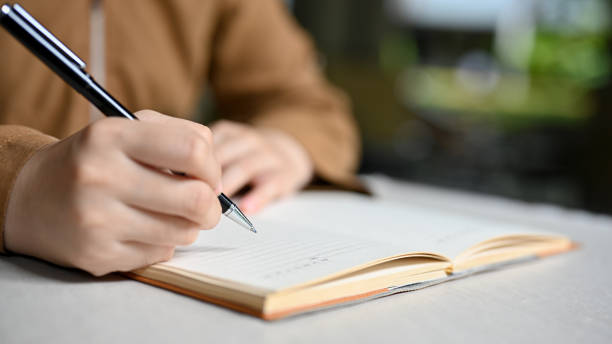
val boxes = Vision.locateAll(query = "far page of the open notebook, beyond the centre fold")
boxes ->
[252,191,551,259]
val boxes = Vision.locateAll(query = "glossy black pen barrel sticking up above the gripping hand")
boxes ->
[0,5,137,120]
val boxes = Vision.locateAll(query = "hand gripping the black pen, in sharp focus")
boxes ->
[5,110,221,276]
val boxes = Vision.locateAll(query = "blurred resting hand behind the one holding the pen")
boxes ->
[211,121,313,214]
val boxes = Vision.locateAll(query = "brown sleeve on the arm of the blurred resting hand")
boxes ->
[211,0,362,190]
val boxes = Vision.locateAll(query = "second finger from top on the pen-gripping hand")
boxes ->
[117,163,221,228]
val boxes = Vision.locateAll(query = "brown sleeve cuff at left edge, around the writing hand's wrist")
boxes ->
[0,125,57,253]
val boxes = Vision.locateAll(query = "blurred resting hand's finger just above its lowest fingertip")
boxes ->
[221,153,278,195]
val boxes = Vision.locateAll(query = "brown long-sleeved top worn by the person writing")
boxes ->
[0,0,359,252]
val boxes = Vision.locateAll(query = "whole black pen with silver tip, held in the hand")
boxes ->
[0,4,257,233]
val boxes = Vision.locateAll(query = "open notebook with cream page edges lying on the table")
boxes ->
[128,191,572,319]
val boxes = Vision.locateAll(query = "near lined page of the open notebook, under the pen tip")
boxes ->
[163,219,403,290]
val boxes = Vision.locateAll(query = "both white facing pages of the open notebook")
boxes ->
[164,192,552,290]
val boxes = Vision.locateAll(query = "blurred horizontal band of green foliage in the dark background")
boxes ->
[402,67,593,125]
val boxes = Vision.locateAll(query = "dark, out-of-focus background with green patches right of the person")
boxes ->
[288,0,612,213]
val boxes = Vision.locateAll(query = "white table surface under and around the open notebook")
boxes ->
[0,176,612,344]
